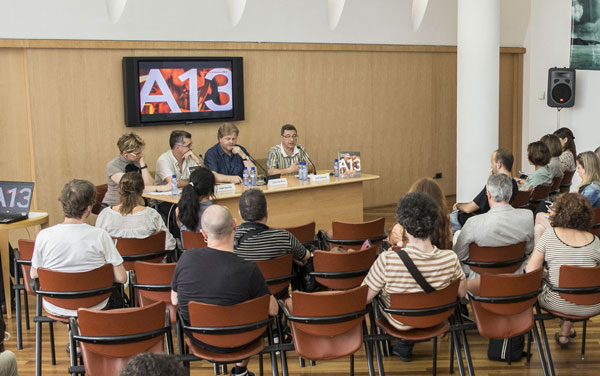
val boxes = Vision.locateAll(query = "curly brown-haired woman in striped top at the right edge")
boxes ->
[526,193,600,348]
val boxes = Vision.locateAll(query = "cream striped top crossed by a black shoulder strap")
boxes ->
[363,246,465,330]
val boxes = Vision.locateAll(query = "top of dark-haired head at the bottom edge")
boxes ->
[119,353,188,376]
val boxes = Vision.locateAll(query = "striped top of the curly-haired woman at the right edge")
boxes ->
[535,228,600,316]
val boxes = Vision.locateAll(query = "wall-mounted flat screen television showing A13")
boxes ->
[123,57,244,127]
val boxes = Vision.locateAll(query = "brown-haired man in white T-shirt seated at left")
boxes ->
[30,179,127,316]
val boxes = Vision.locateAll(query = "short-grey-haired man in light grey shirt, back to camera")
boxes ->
[454,174,533,279]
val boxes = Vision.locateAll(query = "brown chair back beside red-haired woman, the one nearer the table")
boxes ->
[321,218,386,250]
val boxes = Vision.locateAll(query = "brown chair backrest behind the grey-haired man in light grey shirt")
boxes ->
[462,242,527,274]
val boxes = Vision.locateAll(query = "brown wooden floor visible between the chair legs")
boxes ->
[6,204,600,376]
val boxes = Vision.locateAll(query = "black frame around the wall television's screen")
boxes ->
[123,56,244,127]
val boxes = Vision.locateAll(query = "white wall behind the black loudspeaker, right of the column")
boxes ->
[523,0,600,181]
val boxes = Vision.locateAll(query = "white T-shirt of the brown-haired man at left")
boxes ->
[31,223,123,316]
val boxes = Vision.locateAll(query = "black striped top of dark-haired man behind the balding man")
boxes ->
[234,222,308,261]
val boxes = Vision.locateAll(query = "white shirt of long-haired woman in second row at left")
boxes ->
[96,208,175,250]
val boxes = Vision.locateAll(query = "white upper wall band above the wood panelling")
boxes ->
[0,0,530,47]
